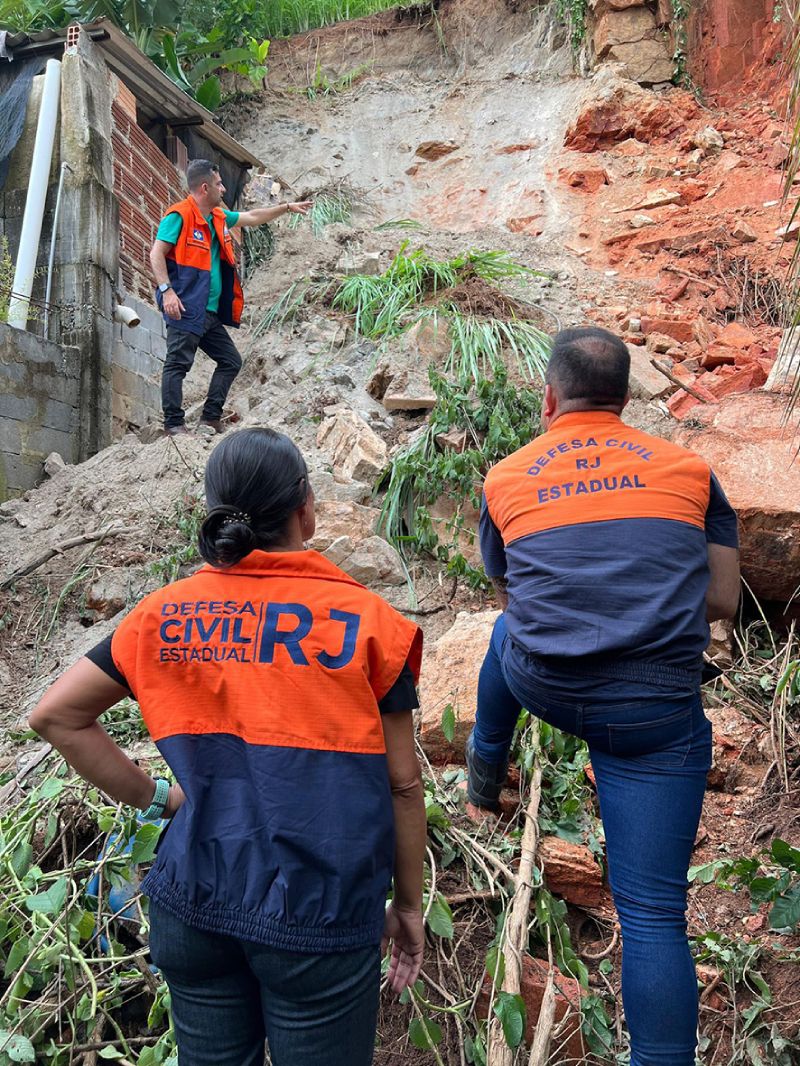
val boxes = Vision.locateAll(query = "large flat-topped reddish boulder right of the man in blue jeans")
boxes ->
[674,391,800,601]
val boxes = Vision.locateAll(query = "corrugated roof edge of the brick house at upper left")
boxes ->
[5,18,265,166]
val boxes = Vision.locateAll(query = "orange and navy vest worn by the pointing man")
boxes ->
[156,196,244,334]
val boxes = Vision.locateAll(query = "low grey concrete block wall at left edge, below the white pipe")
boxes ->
[0,323,81,500]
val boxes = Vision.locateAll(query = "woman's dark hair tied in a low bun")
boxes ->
[198,430,308,567]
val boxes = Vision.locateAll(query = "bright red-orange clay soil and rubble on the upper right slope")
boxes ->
[558,31,800,418]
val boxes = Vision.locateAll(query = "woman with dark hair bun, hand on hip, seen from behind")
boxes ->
[30,430,426,1066]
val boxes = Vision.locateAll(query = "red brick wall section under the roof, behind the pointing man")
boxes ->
[111,82,186,304]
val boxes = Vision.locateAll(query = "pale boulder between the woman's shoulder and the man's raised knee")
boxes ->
[419,611,500,763]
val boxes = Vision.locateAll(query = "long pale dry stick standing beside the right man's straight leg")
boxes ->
[489,738,542,1066]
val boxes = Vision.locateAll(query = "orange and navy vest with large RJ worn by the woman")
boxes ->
[112,551,421,952]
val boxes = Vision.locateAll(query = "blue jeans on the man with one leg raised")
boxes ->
[473,615,711,1066]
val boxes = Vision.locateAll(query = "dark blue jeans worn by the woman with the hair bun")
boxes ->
[150,902,381,1066]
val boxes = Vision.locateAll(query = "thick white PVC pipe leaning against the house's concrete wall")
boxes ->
[7,60,61,329]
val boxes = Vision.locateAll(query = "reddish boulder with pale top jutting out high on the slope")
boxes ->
[564,69,699,151]
